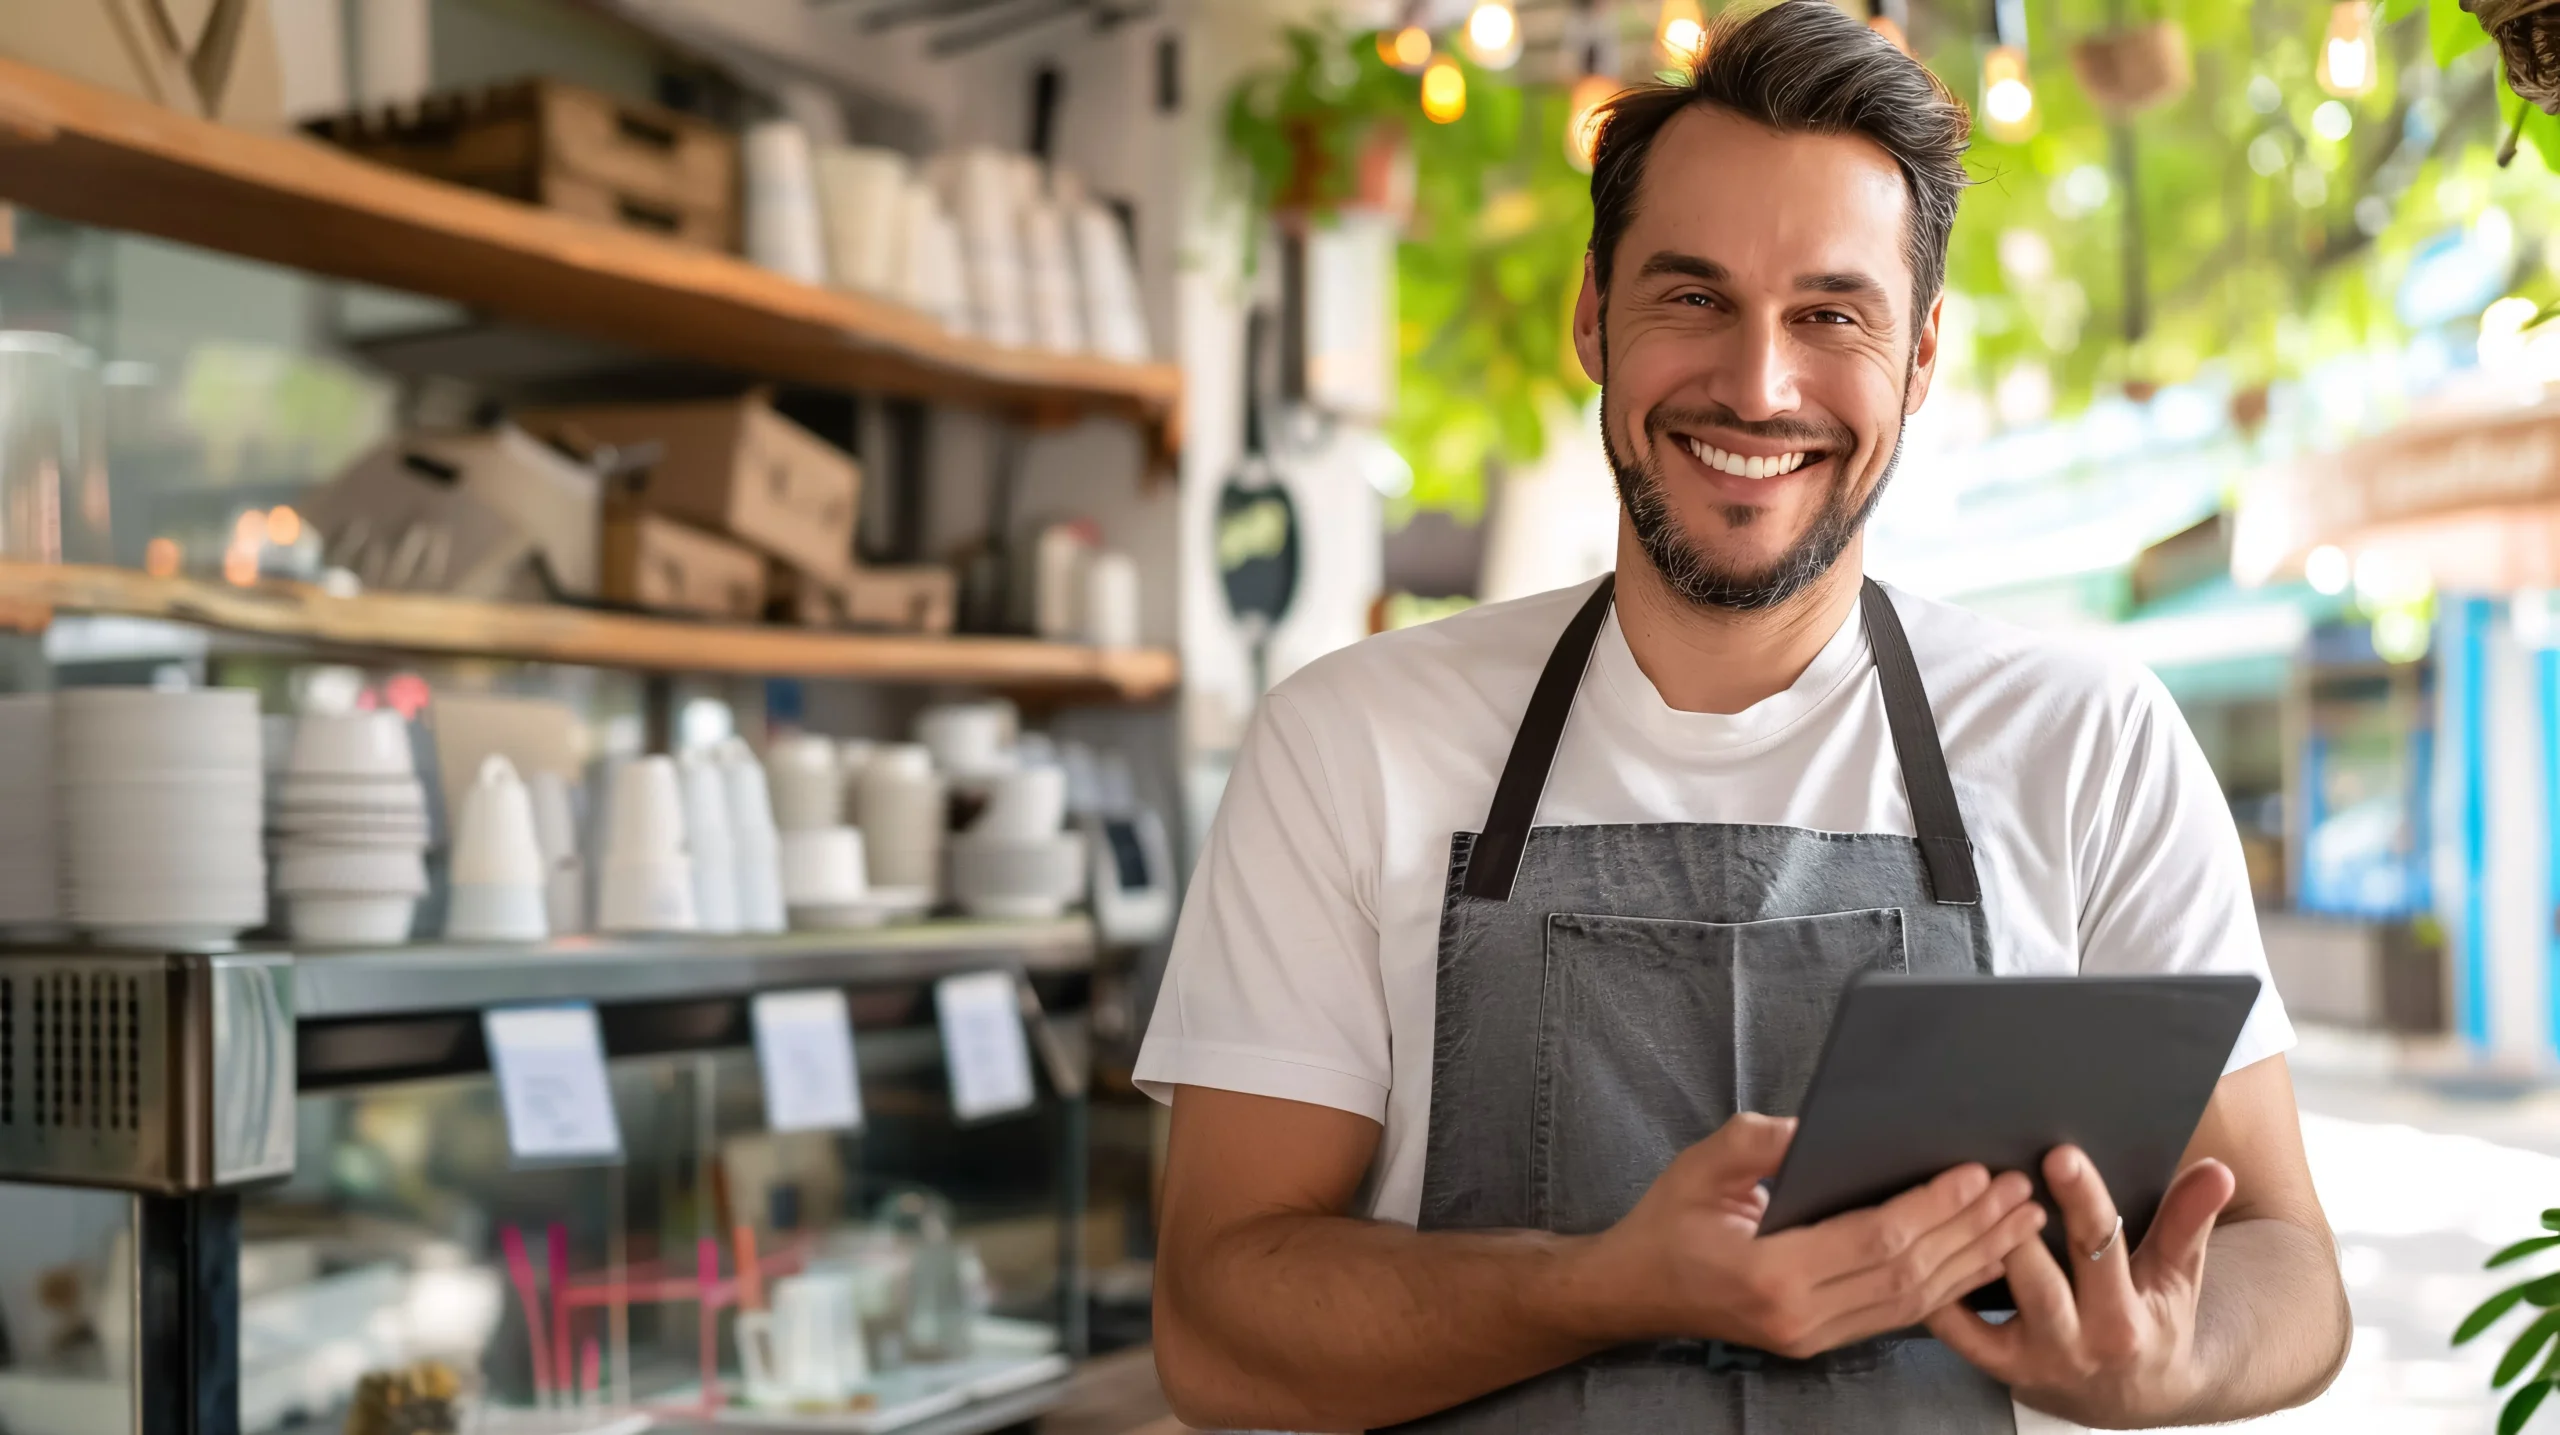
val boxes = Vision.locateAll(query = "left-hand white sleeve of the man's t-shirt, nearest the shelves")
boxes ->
[1137,691,1390,1123]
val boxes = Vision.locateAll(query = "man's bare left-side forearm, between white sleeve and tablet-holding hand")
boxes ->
[1157,1212,1638,1430]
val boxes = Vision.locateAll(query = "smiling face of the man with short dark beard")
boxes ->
[1574,105,1938,609]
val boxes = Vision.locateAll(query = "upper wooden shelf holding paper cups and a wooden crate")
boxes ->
[0,61,1183,447]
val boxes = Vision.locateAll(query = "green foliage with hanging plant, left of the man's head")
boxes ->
[1226,26,1590,517]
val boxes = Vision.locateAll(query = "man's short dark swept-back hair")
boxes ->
[1592,0,1974,320]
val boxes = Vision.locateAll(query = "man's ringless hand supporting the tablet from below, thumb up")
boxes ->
[1592,1113,2048,1358]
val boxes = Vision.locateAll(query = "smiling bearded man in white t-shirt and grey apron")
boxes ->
[1139,0,2348,1432]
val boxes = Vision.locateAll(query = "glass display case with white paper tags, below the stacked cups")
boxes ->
[0,918,1093,1435]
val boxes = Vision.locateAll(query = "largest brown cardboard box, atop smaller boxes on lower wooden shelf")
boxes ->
[517,394,863,578]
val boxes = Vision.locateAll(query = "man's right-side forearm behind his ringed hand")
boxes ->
[2179,1218,2353,1425]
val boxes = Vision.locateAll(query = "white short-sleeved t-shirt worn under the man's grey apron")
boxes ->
[1137,575,2294,1223]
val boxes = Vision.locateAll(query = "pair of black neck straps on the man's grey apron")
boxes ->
[1462,573,1981,906]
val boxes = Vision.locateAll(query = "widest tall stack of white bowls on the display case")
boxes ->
[54,688,266,949]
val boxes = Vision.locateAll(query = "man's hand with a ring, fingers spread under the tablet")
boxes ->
[1928,1146,2237,1427]
